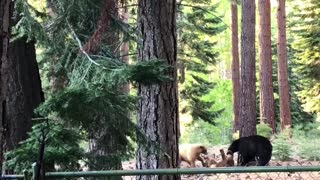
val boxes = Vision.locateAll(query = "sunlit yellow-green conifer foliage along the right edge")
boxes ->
[289,0,320,114]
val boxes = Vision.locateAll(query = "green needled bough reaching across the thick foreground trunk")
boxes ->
[69,57,173,90]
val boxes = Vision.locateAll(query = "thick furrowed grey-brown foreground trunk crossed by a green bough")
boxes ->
[136,0,180,179]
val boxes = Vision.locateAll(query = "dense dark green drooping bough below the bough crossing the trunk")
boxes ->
[39,84,135,158]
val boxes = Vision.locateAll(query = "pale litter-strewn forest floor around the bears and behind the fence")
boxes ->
[122,146,320,180]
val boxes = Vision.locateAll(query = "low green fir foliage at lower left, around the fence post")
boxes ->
[5,120,84,174]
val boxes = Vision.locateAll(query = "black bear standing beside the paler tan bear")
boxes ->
[227,135,272,166]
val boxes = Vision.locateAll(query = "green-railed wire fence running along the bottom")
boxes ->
[1,166,320,180]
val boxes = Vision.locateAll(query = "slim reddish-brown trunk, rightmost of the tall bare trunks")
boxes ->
[277,0,291,130]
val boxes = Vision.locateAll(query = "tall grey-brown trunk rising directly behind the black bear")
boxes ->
[240,0,257,137]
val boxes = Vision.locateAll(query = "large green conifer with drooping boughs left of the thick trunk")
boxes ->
[8,0,158,172]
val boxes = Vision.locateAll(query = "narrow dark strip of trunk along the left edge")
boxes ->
[0,0,12,173]
